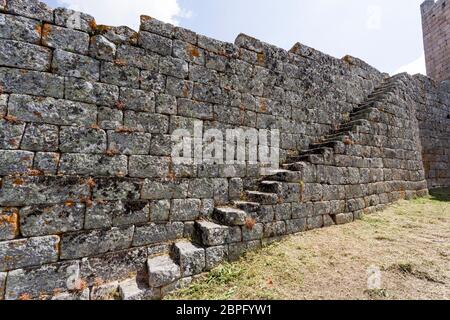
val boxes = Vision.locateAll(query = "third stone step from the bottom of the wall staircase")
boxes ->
[172,242,206,277]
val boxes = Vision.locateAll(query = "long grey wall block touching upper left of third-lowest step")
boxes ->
[133,222,184,246]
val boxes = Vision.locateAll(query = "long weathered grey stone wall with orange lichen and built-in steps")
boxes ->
[0,0,449,299]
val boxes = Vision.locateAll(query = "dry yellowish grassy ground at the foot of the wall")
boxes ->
[166,189,450,300]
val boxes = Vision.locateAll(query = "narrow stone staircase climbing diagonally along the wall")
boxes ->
[104,77,404,300]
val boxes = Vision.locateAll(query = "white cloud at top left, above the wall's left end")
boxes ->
[57,0,190,30]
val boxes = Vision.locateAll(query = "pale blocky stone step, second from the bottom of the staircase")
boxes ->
[147,256,181,288]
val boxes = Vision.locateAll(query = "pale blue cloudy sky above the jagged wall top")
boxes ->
[44,0,424,73]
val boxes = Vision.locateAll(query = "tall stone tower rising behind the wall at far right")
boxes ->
[421,0,450,82]
